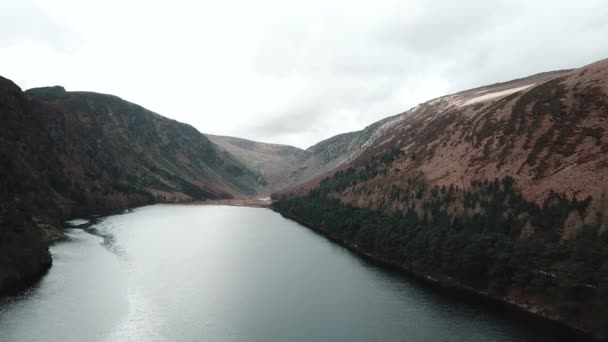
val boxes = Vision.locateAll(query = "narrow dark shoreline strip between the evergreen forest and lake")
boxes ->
[270,206,607,342]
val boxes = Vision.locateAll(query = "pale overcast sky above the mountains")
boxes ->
[0,0,608,148]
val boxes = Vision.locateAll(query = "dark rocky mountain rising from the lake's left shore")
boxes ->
[0,78,258,292]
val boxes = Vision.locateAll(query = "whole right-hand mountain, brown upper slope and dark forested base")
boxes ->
[273,60,608,338]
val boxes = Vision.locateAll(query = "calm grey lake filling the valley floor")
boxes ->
[0,205,567,342]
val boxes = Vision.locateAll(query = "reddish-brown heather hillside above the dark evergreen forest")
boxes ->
[277,60,608,206]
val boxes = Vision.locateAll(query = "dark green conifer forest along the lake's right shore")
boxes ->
[273,151,608,334]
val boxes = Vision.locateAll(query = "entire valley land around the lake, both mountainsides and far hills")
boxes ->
[0,60,608,339]
